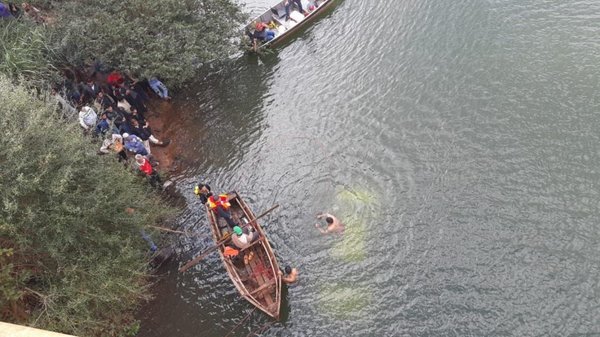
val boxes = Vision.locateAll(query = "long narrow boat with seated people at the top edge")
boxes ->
[245,0,336,51]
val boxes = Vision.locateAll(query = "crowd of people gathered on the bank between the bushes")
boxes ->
[52,71,170,186]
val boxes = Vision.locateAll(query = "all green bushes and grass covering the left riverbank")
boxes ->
[0,0,245,336]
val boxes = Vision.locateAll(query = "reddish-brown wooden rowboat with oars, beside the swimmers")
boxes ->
[206,192,281,319]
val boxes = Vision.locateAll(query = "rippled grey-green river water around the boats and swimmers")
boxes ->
[139,0,600,337]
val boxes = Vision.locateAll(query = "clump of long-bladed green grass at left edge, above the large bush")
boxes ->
[0,20,55,84]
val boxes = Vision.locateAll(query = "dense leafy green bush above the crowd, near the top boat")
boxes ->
[49,0,243,86]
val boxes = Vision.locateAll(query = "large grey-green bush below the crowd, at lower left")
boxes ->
[0,76,171,336]
